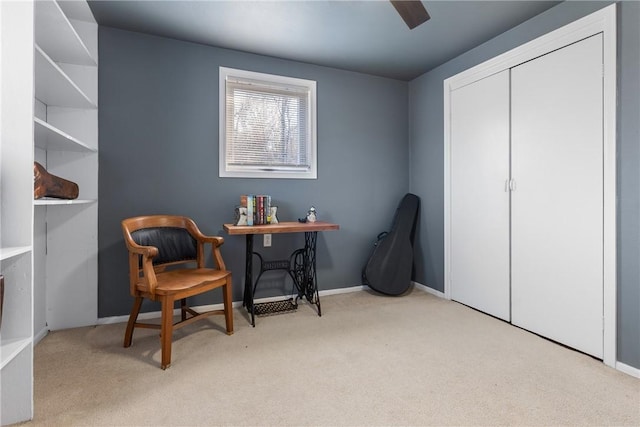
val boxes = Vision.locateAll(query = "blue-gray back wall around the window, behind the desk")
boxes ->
[98,27,409,317]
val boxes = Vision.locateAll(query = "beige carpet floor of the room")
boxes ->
[26,290,640,426]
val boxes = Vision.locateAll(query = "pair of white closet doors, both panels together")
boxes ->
[449,34,604,358]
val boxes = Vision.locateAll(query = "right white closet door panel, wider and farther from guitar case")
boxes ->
[511,35,603,358]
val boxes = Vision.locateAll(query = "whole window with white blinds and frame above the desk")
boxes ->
[219,67,317,179]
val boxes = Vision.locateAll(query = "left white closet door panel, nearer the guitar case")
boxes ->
[449,70,509,321]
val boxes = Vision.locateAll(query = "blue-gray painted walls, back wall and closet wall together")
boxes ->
[99,2,640,368]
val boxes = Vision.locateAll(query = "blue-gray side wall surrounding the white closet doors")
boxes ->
[409,1,640,368]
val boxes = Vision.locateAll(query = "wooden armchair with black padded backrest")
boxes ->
[122,215,233,369]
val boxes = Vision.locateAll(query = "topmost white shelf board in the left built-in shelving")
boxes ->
[35,0,96,65]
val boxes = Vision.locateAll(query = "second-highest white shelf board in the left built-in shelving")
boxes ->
[34,45,98,108]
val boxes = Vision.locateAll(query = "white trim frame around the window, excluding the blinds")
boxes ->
[218,67,318,179]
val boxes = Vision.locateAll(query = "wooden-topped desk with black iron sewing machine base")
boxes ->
[223,221,340,327]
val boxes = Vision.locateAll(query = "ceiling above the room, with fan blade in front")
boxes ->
[89,0,559,80]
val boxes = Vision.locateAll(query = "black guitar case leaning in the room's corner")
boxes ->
[362,193,420,295]
